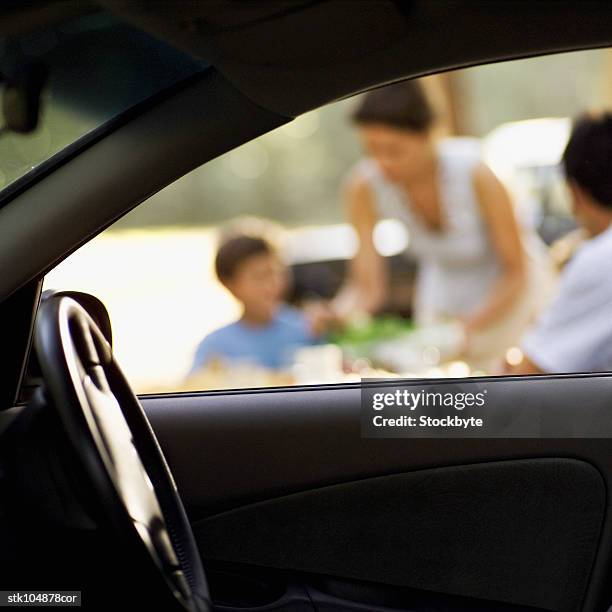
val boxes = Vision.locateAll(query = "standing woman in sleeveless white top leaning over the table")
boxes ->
[334,76,556,364]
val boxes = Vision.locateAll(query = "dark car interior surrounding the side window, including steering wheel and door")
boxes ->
[0,0,612,612]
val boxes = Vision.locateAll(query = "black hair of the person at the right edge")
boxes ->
[563,112,612,208]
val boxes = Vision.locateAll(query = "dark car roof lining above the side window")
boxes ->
[97,0,612,117]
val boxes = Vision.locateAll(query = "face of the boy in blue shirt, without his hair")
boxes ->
[225,253,287,321]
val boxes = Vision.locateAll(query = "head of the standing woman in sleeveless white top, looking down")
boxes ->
[352,80,434,182]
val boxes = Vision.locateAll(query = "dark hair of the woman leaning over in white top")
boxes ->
[352,81,434,132]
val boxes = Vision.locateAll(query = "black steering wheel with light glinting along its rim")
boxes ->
[36,295,211,612]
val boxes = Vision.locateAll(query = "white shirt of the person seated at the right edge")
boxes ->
[522,225,612,372]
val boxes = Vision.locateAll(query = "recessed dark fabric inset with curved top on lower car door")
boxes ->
[194,459,606,612]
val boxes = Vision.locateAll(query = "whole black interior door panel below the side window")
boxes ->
[142,375,612,611]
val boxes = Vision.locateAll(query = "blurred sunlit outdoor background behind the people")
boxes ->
[10,31,612,393]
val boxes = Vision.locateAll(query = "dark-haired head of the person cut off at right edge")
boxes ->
[563,112,612,235]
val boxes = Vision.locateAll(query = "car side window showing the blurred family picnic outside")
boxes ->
[45,49,612,393]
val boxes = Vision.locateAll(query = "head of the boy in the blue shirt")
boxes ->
[215,235,287,323]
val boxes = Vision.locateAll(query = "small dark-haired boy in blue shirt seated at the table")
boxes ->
[190,235,326,374]
